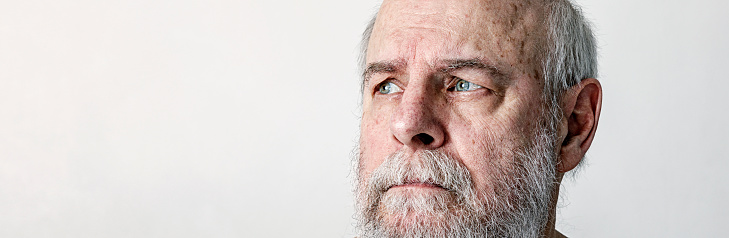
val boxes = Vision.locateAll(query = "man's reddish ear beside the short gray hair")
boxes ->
[557,78,602,173]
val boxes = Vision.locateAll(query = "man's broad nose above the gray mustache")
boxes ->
[390,87,445,150]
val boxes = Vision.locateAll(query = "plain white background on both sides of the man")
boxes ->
[0,0,729,237]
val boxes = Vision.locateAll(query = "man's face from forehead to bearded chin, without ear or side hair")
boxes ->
[358,0,554,236]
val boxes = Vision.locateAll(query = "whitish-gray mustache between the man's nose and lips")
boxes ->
[367,150,474,198]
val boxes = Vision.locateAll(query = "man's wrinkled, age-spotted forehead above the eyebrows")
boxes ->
[366,0,543,75]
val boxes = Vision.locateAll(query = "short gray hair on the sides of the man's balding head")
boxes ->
[359,0,597,171]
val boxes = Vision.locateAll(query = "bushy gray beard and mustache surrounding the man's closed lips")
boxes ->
[356,129,558,238]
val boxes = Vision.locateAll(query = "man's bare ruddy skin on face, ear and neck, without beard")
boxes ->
[359,0,602,237]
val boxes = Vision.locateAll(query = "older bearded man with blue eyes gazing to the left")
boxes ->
[356,0,602,237]
